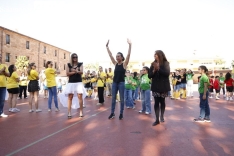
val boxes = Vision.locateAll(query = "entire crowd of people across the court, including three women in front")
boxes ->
[0,40,234,126]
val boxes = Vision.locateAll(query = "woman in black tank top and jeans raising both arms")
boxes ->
[106,39,132,120]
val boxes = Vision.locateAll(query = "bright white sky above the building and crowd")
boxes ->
[0,0,234,62]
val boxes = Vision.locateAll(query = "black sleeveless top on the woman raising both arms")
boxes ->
[113,63,126,83]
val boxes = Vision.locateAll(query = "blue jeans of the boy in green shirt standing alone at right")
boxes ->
[200,92,210,119]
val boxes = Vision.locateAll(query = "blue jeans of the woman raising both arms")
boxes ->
[111,82,125,114]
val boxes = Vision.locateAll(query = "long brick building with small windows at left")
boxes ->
[0,26,70,76]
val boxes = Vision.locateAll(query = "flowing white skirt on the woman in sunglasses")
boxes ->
[58,82,87,109]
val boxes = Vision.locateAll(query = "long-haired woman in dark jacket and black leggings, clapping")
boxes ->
[148,50,171,126]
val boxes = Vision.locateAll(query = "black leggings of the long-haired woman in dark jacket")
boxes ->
[154,97,166,122]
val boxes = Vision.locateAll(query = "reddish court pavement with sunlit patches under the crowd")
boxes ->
[0,92,234,156]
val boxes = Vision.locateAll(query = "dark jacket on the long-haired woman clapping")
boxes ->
[148,61,171,93]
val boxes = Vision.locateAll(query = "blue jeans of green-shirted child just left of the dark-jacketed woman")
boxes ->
[141,89,151,113]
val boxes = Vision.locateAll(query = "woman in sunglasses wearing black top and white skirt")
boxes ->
[64,53,84,118]
